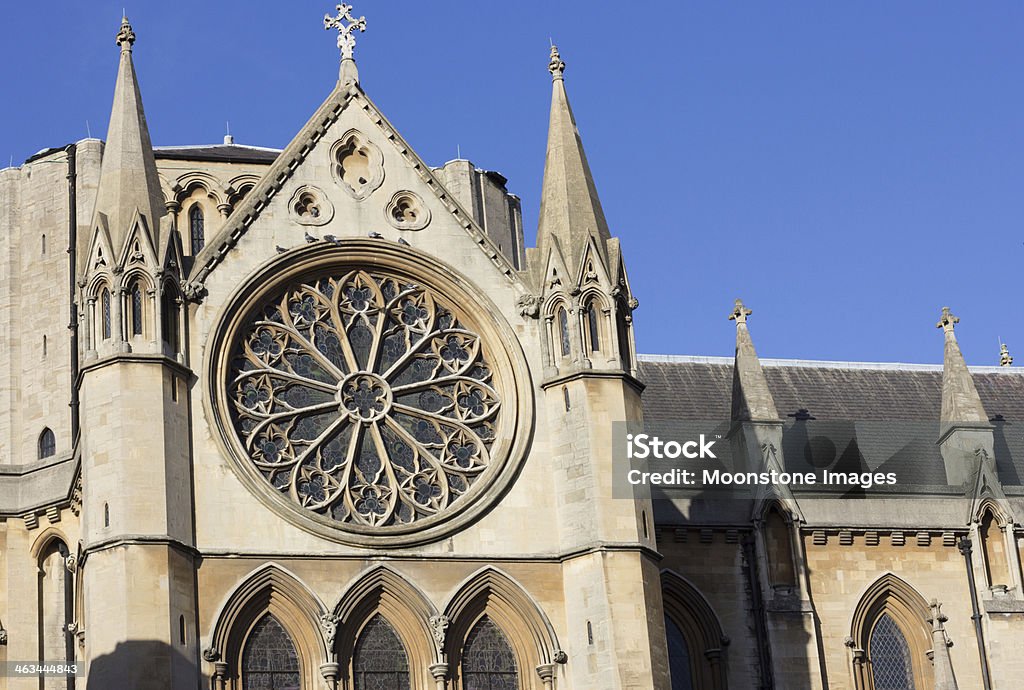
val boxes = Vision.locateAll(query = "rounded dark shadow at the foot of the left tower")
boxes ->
[86,640,210,690]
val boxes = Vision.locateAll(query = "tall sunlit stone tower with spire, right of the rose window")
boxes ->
[527,46,668,688]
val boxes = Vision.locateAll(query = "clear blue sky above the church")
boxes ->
[0,0,1024,364]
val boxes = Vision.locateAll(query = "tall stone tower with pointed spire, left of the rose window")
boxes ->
[76,18,197,688]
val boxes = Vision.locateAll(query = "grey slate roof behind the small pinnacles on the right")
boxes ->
[638,355,1024,486]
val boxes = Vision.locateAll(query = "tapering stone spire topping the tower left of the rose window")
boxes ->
[96,17,164,252]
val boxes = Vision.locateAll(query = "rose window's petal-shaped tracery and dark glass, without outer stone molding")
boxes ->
[232,270,501,527]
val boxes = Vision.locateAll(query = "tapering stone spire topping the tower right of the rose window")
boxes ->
[537,45,611,270]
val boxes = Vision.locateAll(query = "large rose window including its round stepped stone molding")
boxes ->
[207,240,534,547]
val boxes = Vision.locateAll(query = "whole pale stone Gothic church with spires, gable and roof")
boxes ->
[0,6,1024,690]
